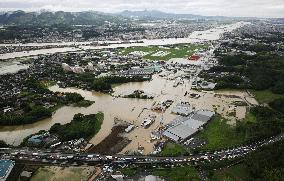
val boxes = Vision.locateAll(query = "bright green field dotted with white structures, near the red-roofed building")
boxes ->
[118,44,208,60]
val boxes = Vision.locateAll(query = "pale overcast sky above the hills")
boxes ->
[0,0,284,18]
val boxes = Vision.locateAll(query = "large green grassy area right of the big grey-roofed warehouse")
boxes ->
[197,115,245,150]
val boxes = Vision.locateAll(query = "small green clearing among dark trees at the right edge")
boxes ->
[250,90,284,104]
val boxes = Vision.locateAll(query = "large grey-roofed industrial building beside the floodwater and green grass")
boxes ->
[163,110,215,142]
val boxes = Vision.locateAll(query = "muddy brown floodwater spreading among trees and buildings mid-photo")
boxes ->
[0,72,255,154]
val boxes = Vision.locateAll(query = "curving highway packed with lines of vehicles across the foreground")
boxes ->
[0,134,284,166]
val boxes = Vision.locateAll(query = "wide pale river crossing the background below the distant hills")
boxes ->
[0,22,248,60]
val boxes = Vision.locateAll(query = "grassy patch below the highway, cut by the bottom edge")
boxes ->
[152,166,200,181]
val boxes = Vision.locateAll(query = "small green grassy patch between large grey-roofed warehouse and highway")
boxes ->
[160,142,188,156]
